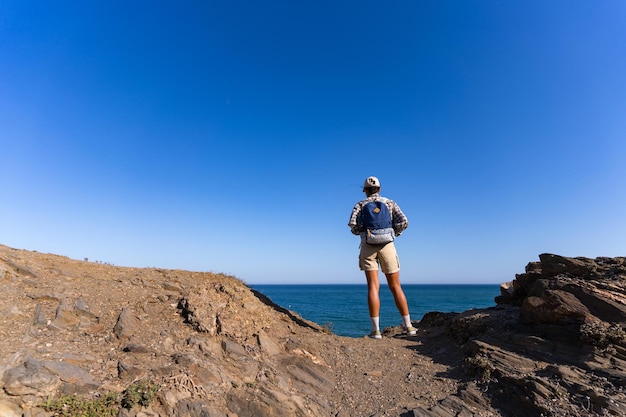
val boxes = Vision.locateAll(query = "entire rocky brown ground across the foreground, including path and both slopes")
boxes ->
[0,246,626,417]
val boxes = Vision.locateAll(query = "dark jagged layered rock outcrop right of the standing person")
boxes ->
[421,254,626,416]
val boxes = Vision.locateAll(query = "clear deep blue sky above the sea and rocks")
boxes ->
[0,0,626,284]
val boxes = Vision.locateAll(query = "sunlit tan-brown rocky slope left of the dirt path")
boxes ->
[0,246,332,417]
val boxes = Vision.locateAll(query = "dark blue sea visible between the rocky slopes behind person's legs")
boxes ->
[251,284,500,337]
